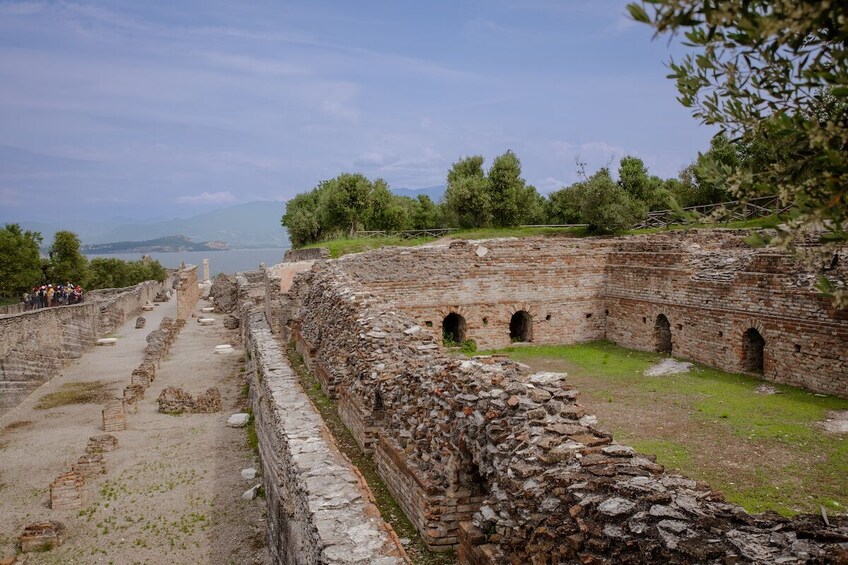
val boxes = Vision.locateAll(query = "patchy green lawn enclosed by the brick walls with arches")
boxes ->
[484,342,848,516]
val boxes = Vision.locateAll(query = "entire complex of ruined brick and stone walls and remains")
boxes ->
[0,230,848,565]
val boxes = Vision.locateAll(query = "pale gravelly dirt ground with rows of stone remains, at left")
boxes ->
[0,300,270,565]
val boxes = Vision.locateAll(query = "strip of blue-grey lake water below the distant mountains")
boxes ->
[87,247,288,277]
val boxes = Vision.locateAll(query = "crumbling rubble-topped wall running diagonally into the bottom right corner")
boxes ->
[289,258,848,563]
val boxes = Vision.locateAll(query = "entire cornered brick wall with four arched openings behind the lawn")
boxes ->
[328,230,848,396]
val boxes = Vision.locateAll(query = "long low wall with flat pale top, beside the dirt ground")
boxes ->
[239,284,408,565]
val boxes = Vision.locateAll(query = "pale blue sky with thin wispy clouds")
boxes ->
[0,0,713,222]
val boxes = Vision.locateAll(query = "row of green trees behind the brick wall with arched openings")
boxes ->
[282,134,773,247]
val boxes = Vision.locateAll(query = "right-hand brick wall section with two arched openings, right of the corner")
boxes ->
[604,233,848,396]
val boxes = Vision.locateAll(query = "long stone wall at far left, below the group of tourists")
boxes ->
[0,281,162,413]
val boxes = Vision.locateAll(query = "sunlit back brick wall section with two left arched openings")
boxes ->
[338,238,608,349]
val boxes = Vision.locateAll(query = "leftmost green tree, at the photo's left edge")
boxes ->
[0,224,42,299]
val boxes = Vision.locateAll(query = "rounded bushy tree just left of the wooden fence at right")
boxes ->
[580,168,648,233]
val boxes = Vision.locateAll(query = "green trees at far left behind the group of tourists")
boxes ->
[0,224,167,299]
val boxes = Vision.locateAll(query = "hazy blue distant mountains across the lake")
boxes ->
[3,201,289,249]
